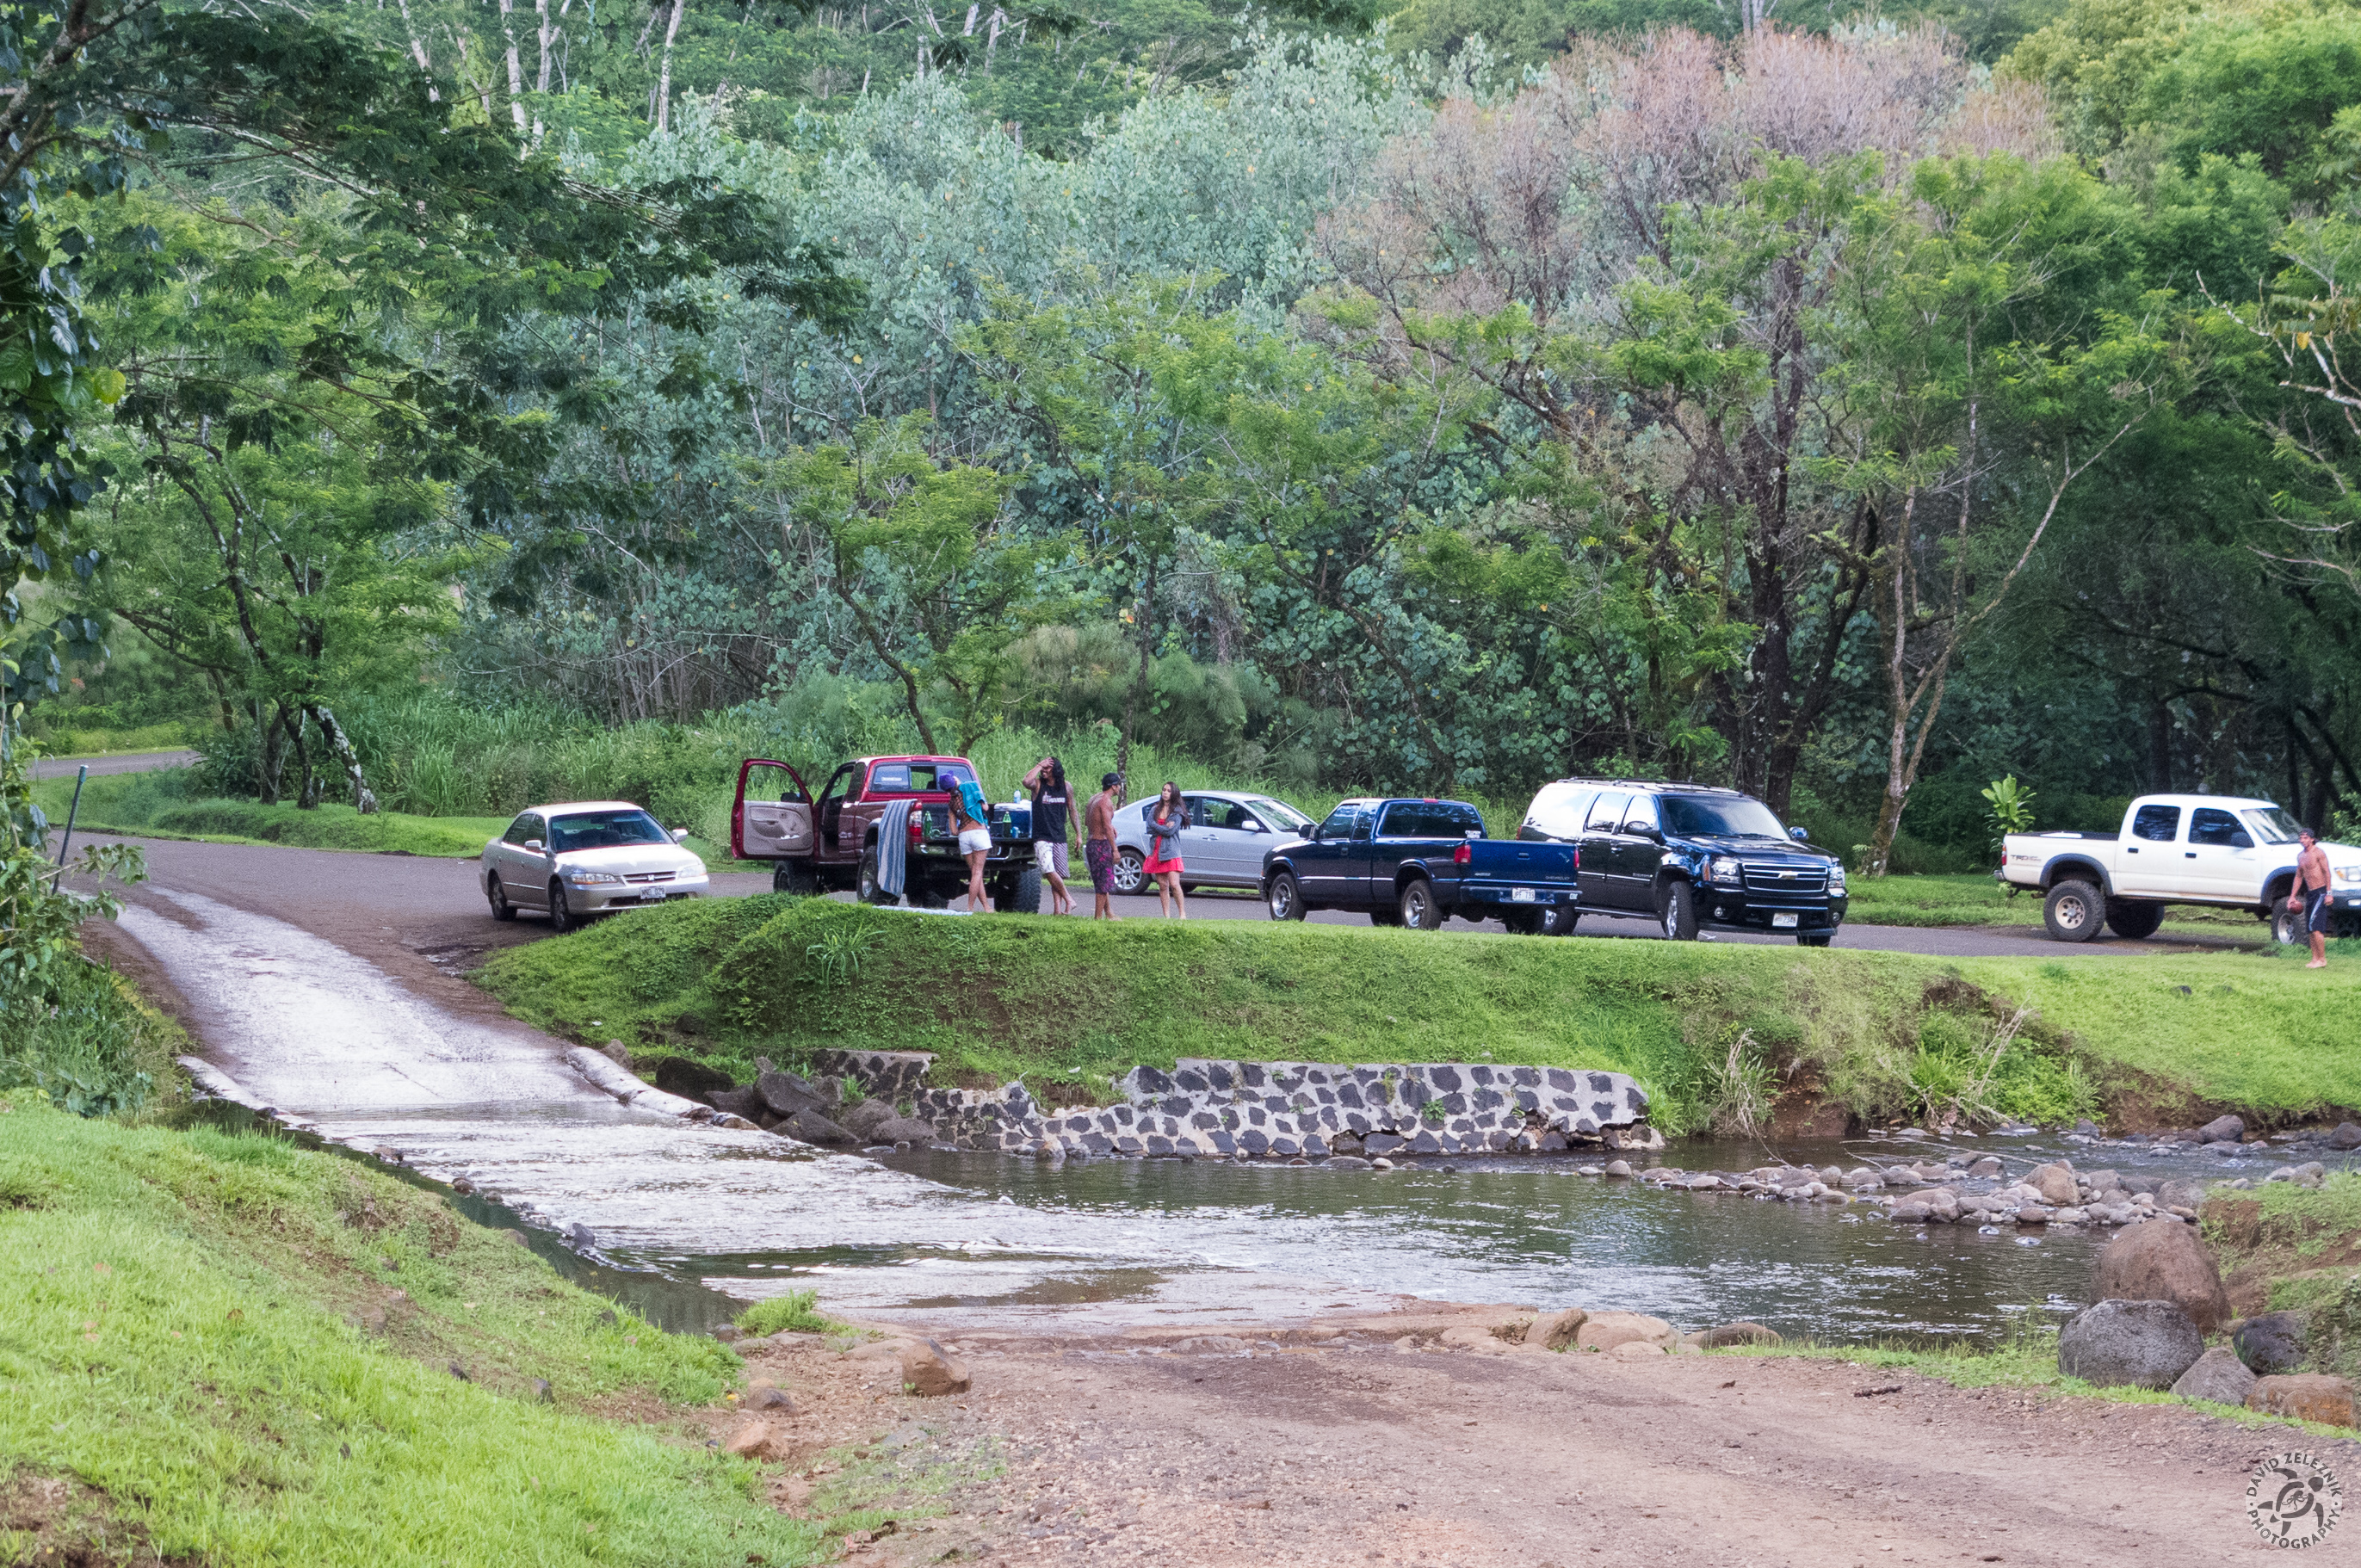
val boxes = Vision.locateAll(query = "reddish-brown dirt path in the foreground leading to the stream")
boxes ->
[749,1304,2361,1568]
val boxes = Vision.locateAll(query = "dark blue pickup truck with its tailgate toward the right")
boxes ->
[1264,800,1575,935]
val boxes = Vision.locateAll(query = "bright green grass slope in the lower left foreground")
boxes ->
[0,1091,817,1568]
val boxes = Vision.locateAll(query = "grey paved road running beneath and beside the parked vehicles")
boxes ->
[78,838,2238,968]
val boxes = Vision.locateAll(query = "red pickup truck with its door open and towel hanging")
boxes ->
[730,756,1041,914]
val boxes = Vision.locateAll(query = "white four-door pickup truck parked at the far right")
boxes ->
[1993,796,2361,942]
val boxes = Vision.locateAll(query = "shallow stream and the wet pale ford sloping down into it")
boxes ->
[125,895,2347,1342]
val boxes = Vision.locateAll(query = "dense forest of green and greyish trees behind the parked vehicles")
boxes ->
[14,0,2361,869]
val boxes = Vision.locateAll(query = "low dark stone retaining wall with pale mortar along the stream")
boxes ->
[813,1051,1648,1159]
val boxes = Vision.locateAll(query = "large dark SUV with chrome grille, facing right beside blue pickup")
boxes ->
[1516,780,1844,947]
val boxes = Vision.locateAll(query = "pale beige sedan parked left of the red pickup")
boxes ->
[484,800,706,930]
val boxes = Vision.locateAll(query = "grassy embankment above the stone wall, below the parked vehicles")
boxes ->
[479,898,2361,1131]
